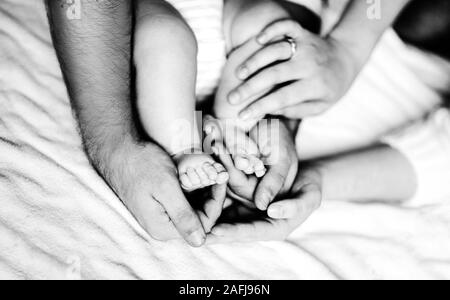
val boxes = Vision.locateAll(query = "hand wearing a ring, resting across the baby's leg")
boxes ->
[229,20,362,120]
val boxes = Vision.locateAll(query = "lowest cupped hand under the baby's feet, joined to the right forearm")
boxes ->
[207,169,322,244]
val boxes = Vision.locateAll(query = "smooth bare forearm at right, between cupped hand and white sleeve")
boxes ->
[313,145,417,201]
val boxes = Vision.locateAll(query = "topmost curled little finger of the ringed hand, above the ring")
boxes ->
[257,19,308,45]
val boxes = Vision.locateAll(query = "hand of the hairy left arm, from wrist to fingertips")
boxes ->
[105,139,226,247]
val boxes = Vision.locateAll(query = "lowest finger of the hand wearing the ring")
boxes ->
[239,80,321,121]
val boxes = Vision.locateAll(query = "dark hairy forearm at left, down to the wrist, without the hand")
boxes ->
[47,0,134,168]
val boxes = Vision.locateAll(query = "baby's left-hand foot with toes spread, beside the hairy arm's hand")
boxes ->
[175,152,229,192]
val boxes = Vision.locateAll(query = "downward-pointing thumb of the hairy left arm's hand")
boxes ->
[154,179,206,247]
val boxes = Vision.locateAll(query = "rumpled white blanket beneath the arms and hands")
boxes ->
[0,0,450,279]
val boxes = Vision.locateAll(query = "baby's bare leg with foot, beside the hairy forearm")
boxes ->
[134,1,228,191]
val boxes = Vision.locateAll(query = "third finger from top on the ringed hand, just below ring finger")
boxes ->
[228,62,299,105]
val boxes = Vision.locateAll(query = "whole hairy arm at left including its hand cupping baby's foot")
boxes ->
[46,0,225,246]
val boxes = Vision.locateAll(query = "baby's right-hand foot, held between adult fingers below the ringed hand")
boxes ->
[204,116,266,178]
